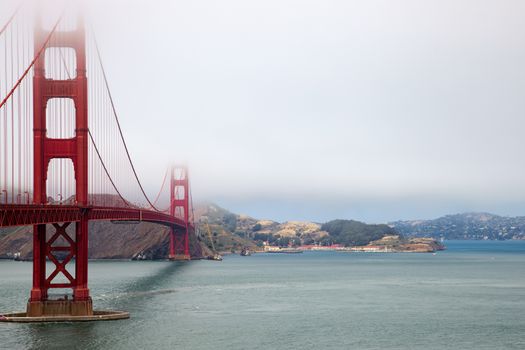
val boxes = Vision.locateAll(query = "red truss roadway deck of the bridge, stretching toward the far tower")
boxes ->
[0,204,186,228]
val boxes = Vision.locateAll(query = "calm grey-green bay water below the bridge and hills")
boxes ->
[0,241,525,350]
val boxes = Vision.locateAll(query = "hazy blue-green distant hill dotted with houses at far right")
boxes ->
[389,213,525,240]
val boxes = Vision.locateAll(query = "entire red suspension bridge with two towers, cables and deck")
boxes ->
[0,7,195,321]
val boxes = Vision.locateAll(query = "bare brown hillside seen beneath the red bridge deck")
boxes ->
[0,222,202,260]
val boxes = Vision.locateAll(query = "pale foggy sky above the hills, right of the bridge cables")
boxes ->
[3,0,525,222]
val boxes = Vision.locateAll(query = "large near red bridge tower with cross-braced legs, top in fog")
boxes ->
[27,20,93,316]
